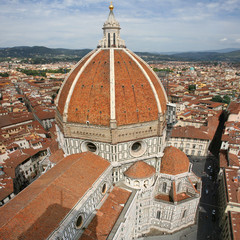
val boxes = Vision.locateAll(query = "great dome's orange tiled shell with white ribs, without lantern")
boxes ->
[57,48,167,126]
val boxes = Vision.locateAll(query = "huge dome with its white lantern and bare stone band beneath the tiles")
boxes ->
[56,4,167,146]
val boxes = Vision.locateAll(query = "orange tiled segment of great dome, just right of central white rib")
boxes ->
[114,51,158,126]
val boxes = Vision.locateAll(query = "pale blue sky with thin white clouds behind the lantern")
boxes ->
[0,0,240,52]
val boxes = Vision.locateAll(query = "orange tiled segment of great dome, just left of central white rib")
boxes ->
[68,49,110,126]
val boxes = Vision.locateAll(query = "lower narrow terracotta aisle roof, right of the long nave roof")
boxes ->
[79,187,131,240]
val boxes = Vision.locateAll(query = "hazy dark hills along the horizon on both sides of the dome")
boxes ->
[0,46,240,63]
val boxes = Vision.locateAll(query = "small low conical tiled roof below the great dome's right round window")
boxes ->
[124,161,156,179]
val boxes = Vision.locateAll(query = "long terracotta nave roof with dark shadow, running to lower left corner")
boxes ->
[0,152,110,240]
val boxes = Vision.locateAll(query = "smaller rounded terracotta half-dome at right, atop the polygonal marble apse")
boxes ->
[160,146,189,175]
